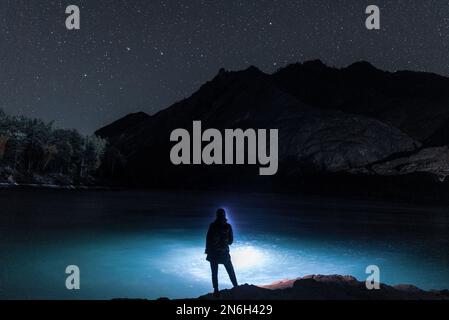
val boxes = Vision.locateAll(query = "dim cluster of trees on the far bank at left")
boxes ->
[0,109,107,181]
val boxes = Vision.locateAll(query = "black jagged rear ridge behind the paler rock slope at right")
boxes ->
[273,61,449,143]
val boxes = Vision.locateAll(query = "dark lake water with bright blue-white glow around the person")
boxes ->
[0,190,449,299]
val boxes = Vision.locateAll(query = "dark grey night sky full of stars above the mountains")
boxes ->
[0,0,449,134]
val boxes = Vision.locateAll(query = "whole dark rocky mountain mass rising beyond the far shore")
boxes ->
[96,61,449,199]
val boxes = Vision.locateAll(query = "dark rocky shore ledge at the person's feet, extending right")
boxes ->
[198,275,449,300]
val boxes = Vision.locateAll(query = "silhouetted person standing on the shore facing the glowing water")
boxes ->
[206,209,238,296]
